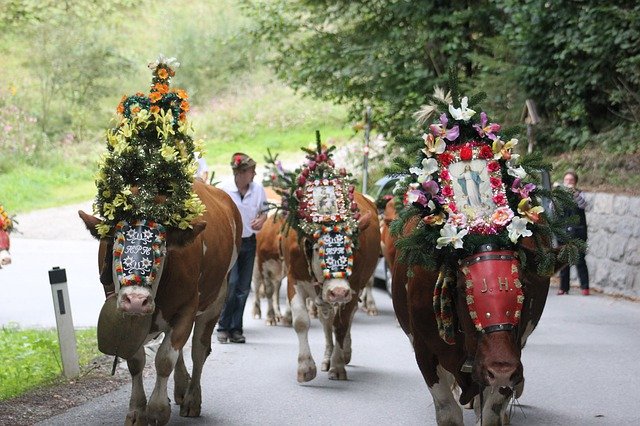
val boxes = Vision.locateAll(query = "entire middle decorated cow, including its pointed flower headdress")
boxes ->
[284,134,380,382]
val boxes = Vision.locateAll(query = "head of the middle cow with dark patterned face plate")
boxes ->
[311,212,371,304]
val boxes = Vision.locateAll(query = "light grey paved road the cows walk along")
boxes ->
[0,209,640,426]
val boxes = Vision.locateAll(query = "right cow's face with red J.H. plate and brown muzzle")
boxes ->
[457,248,524,388]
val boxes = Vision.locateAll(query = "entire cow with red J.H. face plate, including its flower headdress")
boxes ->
[392,83,584,425]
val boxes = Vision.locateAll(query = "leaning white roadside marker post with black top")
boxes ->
[49,266,80,379]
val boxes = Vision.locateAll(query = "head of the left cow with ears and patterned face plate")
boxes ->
[79,211,206,315]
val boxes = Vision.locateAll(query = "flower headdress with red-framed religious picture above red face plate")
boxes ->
[390,72,584,274]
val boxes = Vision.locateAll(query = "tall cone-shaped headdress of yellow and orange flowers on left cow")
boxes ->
[94,55,204,236]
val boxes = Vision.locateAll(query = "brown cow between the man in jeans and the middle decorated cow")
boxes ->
[253,213,286,325]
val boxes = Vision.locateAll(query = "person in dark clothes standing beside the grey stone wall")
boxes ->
[558,171,589,296]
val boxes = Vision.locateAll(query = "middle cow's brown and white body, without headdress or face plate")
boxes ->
[284,193,380,382]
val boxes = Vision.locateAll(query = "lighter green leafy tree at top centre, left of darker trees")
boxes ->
[244,0,499,131]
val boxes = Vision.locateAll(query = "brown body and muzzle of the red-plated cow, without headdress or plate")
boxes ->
[392,226,550,425]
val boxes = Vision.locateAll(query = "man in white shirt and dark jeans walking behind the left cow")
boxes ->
[218,152,267,343]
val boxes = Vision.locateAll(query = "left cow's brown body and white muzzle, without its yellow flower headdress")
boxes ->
[79,181,242,425]
